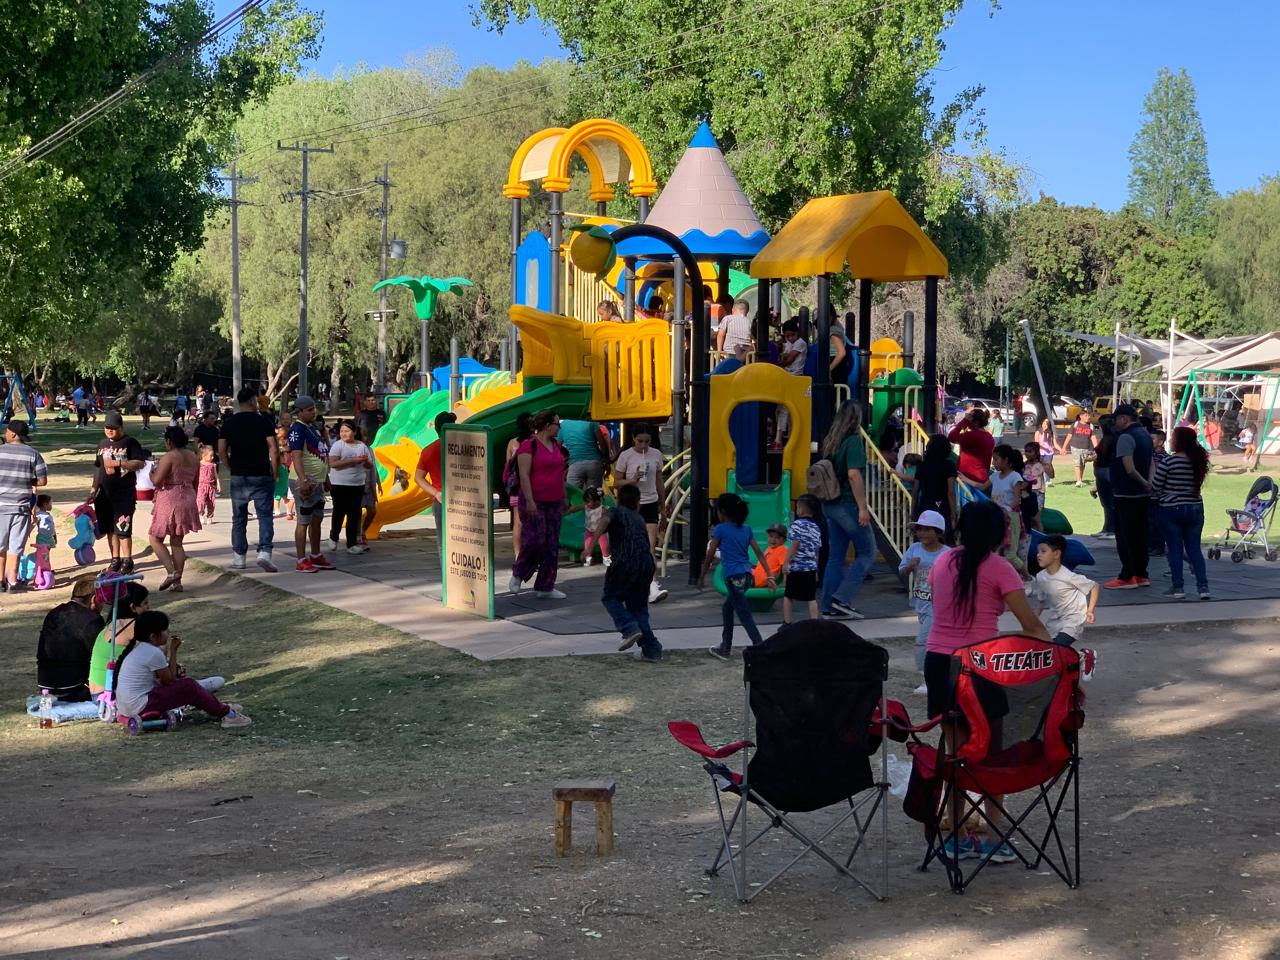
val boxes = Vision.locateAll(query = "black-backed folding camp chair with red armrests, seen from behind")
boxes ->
[667,621,906,904]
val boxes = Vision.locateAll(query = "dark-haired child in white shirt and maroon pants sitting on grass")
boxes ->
[113,611,253,730]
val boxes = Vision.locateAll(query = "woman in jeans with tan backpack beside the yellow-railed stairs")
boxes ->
[814,401,876,620]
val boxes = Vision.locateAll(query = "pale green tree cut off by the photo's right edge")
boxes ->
[1204,178,1280,333]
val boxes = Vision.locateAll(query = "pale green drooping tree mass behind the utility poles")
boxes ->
[201,51,573,394]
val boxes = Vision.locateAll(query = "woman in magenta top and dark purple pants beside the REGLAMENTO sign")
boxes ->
[507,410,567,600]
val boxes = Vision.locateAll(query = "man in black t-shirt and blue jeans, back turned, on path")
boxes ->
[217,387,280,573]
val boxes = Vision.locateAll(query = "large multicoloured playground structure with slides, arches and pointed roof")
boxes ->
[370,119,947,593]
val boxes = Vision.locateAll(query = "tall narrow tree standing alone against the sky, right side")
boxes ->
[1129,68,1215,236]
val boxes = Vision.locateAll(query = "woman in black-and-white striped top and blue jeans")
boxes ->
[1151,426,1213,600]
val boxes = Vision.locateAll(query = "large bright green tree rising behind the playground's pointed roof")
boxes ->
[476,0,1018,285]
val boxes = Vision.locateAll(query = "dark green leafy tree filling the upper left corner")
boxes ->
[0,0,320,362]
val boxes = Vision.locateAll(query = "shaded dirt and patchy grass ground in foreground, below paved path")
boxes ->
[0,430,1280,960]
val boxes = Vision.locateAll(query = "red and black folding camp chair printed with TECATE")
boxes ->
[902,636,1084,893]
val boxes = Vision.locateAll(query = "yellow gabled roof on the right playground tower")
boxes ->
[751,189,947,283]
